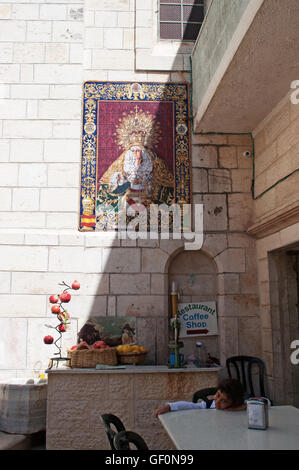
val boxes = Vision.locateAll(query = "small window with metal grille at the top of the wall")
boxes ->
[159,0,205,41]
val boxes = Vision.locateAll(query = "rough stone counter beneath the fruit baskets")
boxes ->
[47,366,221,450]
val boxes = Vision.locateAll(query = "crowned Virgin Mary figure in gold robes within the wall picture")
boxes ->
[96,106,174,230]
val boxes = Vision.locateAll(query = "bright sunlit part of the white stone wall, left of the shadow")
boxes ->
[0,0,191,378]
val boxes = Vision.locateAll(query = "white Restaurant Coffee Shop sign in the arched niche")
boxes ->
[178,302,218,338]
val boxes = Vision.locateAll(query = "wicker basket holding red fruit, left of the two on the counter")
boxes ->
[67,348,117,369]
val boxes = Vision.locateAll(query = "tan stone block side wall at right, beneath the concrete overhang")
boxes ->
[254,93,299,223]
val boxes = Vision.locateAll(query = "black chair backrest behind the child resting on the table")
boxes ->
[226,356,266,399]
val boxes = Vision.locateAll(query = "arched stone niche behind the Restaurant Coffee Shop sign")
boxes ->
[168,250,220,359]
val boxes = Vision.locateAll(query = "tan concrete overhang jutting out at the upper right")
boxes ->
[192,0,299,133]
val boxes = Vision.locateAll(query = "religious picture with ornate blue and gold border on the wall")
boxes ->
[79,82,191,232]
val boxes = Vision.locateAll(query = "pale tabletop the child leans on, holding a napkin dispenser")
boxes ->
[159,406,299,450]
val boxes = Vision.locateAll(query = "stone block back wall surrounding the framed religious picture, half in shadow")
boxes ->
[0,0,260,378]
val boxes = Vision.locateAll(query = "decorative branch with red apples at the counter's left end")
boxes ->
[44,281,80,359]
